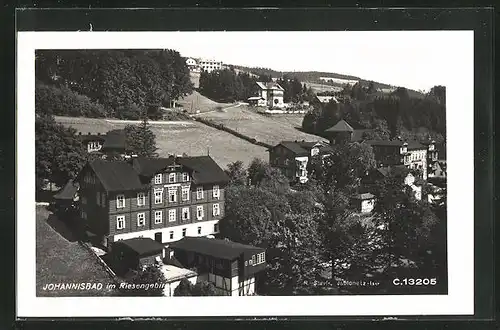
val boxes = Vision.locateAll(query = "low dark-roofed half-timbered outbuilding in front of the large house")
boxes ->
[168,237,266,296]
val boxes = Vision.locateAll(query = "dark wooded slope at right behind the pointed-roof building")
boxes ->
[302,84,446,143]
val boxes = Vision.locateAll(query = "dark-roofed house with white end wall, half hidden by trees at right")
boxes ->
[361,165,423,200]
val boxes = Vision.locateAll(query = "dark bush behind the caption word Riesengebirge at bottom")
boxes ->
[126,265,166,296]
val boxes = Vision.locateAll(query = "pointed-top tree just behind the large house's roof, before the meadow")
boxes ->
[125,117,158,157]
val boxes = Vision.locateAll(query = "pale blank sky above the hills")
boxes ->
[150,31,463,91]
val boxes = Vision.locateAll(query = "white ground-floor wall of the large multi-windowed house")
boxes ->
[114,220,219,243]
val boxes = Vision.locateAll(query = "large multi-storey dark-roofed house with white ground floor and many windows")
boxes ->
[78,156,229,248]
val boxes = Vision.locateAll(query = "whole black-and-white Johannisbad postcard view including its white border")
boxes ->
[17,26,473,316]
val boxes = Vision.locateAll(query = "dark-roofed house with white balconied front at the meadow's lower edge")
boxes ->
[268,141,333,183]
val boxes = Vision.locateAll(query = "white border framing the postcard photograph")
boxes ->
[16,31,474,317]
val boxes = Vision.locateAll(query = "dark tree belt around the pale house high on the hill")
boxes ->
[199,69,313,103]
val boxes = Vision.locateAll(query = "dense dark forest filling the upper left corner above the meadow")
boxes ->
[36,50,193,119]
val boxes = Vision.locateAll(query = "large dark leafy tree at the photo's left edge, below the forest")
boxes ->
[35,115,87,190]
